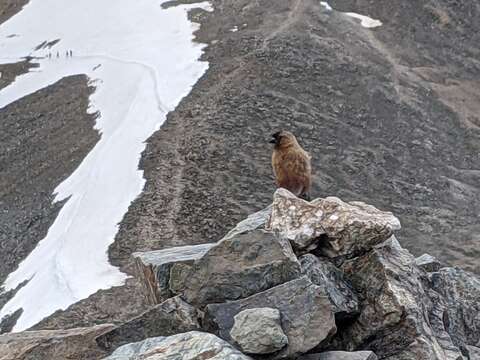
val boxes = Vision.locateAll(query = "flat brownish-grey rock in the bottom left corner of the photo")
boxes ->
[0,324,114,360]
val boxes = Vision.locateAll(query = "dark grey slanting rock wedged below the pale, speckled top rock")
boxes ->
[299,254,359,322]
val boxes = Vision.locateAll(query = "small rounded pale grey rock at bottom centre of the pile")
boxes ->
[230,308,288,354]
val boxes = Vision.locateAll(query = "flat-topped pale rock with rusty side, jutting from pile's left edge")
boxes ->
[133,244,215,304]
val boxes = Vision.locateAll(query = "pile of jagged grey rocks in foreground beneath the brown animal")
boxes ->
[0,189,480,360]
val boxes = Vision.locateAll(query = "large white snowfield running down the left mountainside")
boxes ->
[0,0,210,331]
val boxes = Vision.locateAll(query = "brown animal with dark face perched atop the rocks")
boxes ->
[270,130,312,200]
